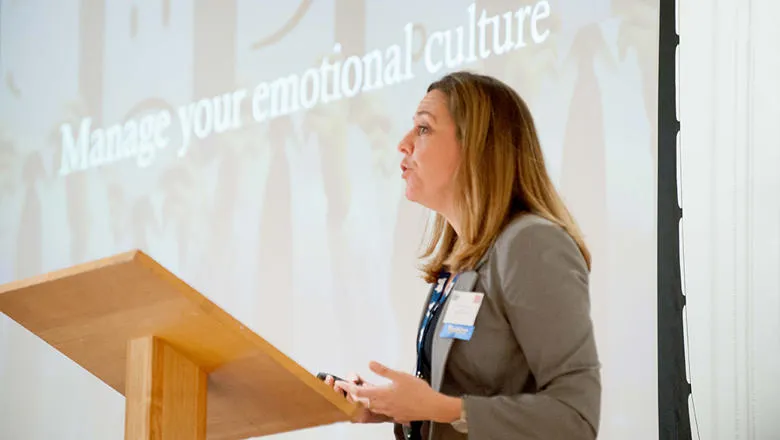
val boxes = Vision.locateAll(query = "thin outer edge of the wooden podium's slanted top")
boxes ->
[0,249,362,430]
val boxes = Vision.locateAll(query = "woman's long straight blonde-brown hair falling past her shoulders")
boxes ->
[421,72,591,282]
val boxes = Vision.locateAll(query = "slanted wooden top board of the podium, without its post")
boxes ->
[0,251,358,439]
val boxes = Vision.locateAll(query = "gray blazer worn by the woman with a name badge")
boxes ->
[394,214,601,440]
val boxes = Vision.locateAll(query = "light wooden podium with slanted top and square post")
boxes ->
[0,251,358,440]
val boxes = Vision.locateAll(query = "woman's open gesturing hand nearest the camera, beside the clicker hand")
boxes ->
[342,362,460,424]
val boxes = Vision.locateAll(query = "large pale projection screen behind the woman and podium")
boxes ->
[0,0,658,440]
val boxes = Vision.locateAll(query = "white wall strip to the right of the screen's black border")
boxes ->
[678,0,780,440]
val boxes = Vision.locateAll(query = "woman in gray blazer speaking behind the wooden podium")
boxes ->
[326,72,601,440]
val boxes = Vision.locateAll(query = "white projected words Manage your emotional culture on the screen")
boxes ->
[59,0,551,176]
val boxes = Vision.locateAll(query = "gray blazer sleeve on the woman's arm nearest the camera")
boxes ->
[463,223,601,440]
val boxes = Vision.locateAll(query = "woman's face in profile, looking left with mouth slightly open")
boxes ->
[398,90,460,216]
